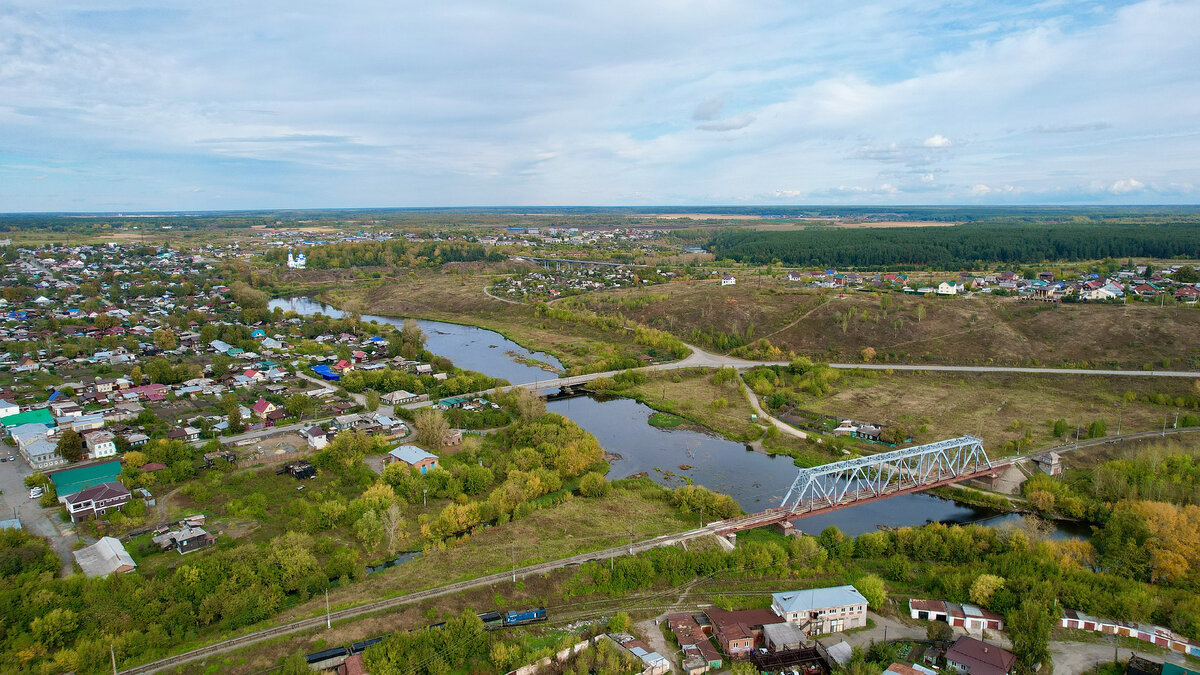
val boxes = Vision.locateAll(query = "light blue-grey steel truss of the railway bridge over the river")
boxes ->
[780,436,992,513]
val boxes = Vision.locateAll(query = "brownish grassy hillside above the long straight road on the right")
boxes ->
[569,275,1200,370]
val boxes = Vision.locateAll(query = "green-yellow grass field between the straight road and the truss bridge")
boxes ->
[802,371,1195,454]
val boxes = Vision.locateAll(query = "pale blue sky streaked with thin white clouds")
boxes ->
[0,0,1200,213]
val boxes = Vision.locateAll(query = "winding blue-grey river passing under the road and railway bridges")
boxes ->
[270,298,1088,538]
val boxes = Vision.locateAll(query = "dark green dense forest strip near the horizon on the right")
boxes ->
[708,220,1200,269]
